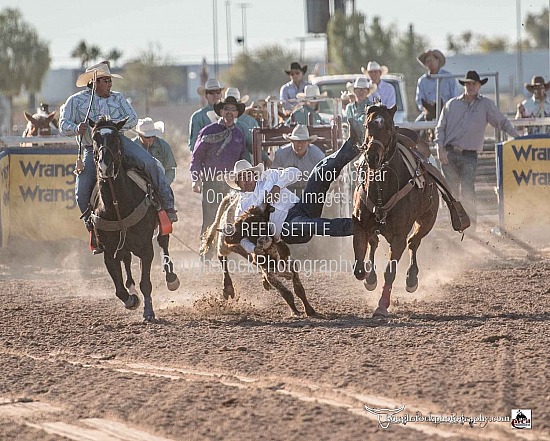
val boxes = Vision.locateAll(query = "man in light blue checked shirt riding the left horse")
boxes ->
[59,61,178,254]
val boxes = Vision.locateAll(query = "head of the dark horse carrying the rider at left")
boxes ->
[88,116,128,179]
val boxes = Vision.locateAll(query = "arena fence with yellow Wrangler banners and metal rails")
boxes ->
[0,72,550,247]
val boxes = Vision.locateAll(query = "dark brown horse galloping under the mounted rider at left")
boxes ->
[88,117,179,321]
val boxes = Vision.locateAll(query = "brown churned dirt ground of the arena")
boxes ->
[0,173,550,441]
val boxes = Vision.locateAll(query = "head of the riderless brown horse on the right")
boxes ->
[364,104,397,170]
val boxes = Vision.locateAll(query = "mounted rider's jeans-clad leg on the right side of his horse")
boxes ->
[122,136,174,215]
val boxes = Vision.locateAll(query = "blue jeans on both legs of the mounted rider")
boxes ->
[75,136,174,213]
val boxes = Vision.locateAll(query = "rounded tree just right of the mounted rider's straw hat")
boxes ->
[121,43,181,115]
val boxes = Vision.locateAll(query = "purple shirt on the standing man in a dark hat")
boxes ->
[189,122,245,182]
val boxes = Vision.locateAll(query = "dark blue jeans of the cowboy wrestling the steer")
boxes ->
[281,141,359,244]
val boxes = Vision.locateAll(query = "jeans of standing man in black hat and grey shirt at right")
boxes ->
[441,150,477,224]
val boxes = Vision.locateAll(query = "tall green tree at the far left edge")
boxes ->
[0,8,51,127]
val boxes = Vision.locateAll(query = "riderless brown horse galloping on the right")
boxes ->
[352,105,439,316]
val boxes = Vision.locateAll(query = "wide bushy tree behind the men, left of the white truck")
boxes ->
[223,45,298,96]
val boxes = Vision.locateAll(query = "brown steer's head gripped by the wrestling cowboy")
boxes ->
[223,204,275,245]
